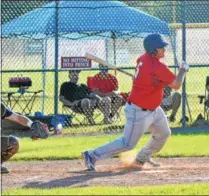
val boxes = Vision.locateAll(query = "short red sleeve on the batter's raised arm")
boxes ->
[154,63,176,85]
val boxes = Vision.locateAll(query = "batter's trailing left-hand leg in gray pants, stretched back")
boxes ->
[86,103,154,160]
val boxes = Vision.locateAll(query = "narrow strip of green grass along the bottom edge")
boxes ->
[2,183,209,195]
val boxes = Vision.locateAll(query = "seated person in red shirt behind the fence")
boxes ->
[88,64,124,120]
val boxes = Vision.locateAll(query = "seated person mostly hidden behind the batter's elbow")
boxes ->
[161,86,181,122]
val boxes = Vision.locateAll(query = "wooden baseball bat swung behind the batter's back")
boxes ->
[85,53,134,78]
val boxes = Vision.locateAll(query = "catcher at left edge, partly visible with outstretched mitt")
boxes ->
[1,103,49,174]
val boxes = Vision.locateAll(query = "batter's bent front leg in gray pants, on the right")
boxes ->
[136,107,171,163]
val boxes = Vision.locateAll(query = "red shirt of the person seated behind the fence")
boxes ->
[87,73,118,93]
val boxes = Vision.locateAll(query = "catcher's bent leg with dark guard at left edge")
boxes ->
[1,136,19,173]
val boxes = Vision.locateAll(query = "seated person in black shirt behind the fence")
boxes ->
[59,70,108,125]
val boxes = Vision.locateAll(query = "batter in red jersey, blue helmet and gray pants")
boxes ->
[82,34,189,170]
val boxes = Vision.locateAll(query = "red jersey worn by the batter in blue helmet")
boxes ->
[128,53,176,110]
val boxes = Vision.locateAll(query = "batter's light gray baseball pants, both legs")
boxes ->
[89,103,171,162]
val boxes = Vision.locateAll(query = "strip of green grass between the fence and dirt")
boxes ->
[11,134,209,161]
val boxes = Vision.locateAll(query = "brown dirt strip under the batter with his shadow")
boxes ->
[2,157,209,190]
